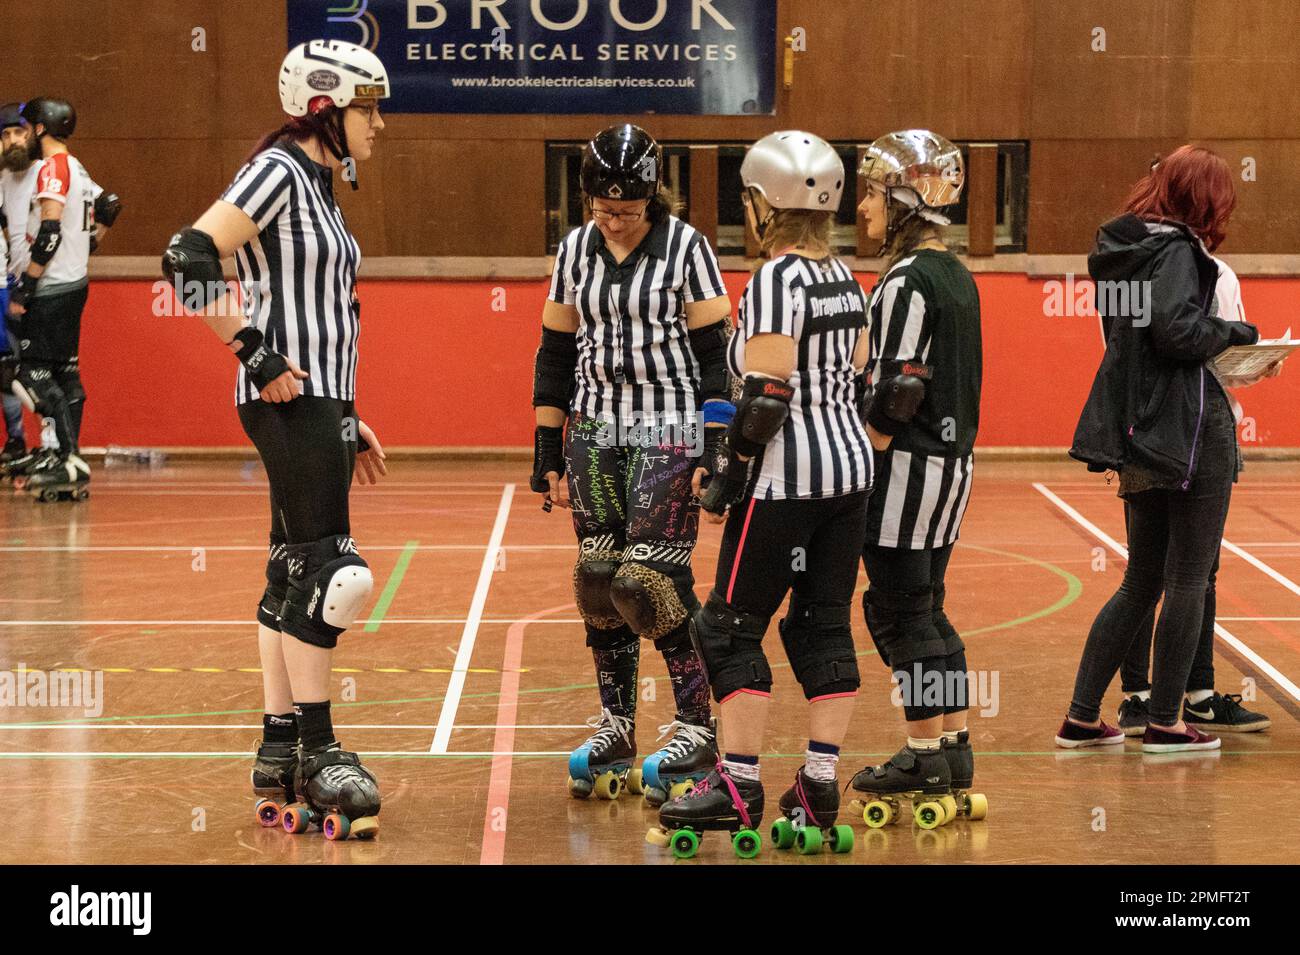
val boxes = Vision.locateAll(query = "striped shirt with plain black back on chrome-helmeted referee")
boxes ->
[867,249,983,551]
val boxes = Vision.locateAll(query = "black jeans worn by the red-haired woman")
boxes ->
[1070,385,1236,726]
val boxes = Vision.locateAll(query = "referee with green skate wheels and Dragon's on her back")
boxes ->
[647,130,872,856]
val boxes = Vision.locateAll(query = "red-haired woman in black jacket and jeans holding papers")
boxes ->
[1056,146,1260,752]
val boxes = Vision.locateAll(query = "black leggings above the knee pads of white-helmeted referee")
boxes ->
[239,396,356,547]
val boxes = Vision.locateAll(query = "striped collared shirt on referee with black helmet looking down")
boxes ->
[547,216,727,426]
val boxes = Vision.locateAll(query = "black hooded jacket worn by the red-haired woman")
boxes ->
[1070,214,1260,487]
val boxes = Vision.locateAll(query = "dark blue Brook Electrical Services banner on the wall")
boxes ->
[287,0,776,116]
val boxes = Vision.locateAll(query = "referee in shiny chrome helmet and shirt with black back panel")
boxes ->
[852,130,987,826]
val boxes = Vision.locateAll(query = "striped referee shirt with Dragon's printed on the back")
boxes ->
[727,255,872,500]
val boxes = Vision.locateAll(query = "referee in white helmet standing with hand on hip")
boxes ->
[163,40,389,838]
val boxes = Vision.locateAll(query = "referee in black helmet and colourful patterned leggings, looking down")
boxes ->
[532,125,731,803]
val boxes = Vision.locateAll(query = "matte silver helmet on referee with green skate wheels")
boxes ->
[740,130,845,212]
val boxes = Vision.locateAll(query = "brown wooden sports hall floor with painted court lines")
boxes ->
[0,461,1300,865]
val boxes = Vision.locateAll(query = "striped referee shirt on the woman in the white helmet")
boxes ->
[221,140,361,404]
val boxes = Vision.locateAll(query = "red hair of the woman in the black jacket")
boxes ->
[1125,146,1236,252]
